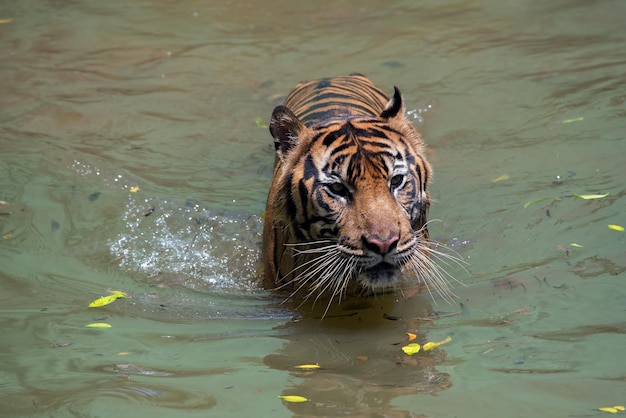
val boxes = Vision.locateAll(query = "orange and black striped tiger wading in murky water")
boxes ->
[263,74,448,303]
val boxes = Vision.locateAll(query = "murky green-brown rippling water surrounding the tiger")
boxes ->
[0,0,626,417]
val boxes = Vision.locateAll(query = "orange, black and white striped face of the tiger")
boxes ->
[285,118,429,288]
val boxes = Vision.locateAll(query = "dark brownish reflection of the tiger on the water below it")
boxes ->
[264,295,452,416]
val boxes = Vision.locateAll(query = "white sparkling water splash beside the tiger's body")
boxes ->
[109,195,262,293]
